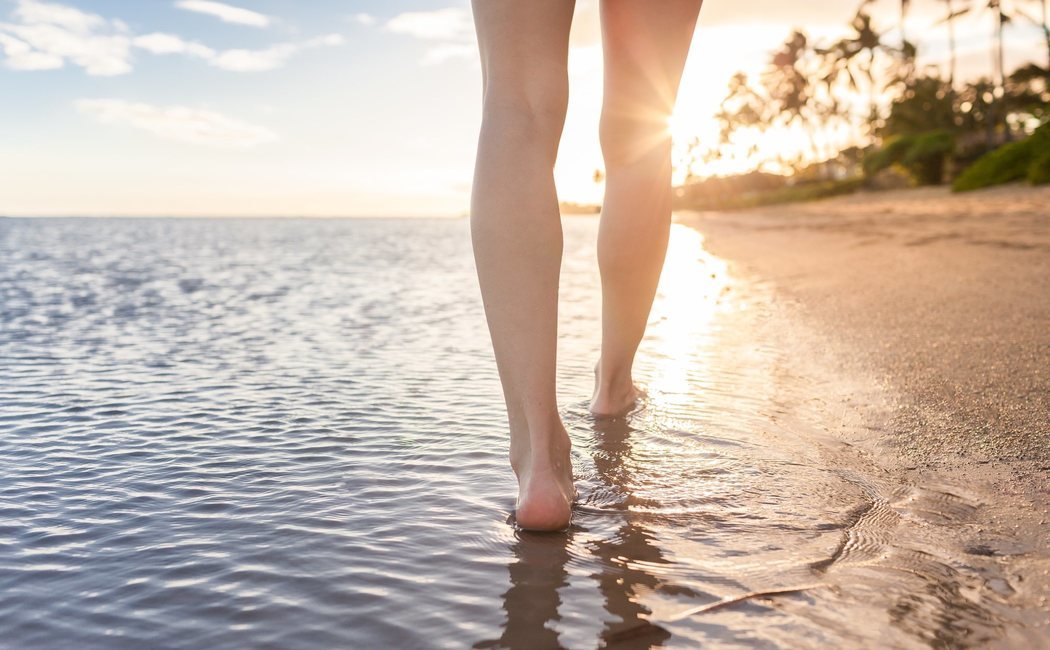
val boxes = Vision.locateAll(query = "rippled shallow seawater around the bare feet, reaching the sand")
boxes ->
[0,217,1033,649]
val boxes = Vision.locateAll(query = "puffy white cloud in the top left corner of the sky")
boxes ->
[0,0,131,76]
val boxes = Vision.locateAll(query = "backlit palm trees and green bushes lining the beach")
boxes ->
[677,0,1050,208]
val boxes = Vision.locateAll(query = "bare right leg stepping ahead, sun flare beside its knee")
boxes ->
[590,0,700,416]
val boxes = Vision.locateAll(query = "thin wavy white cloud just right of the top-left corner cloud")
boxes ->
[133,33,343,72]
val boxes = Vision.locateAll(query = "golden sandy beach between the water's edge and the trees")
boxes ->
[679,186,1050,646]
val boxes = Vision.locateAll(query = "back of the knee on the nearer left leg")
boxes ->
[482,76,569,153]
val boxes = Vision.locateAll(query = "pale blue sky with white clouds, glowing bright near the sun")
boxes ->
[0,0,1046,216]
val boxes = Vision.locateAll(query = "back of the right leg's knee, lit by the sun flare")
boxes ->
[599,107,671,169]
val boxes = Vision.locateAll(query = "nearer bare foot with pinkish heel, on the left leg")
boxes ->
[510,428,576,530]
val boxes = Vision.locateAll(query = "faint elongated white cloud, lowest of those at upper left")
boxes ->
[75,99,277,148]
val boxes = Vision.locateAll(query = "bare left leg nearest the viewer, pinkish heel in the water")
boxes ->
[470,0,575,530]
